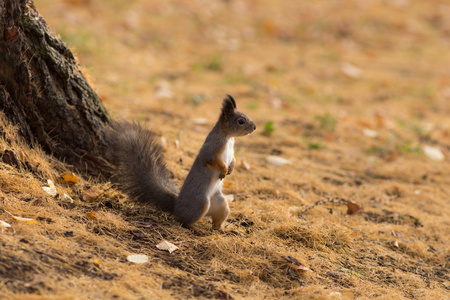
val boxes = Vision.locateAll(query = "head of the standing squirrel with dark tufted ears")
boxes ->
[219,95,256,137]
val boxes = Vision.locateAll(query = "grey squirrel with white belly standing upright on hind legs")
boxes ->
[105,95,256,229]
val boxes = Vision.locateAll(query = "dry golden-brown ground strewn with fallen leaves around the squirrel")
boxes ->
[0,0,450,300]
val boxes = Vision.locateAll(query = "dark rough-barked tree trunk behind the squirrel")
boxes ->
[0,0,109,173]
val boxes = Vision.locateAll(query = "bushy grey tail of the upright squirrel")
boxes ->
[105,122,179,213]
